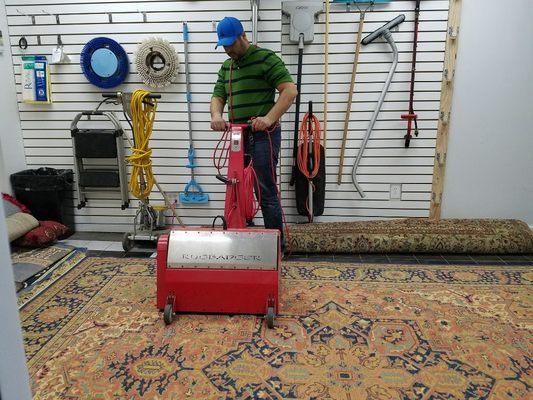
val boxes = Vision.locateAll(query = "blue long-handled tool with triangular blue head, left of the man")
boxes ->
[179,22,209,204]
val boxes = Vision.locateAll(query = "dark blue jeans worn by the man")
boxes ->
[245,126,285,251]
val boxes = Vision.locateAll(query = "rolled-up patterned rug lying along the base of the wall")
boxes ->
[289,218,533,254]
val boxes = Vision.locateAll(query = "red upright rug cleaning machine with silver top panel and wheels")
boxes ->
[157,124,281,328]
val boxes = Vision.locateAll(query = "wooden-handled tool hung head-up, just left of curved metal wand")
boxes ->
[333,0,390,185]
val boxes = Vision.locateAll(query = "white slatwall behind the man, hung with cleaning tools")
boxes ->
[6,0,448,231]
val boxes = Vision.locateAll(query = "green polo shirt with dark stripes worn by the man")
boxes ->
[212,45,293,123]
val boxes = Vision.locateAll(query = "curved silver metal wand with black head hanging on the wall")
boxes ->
[352,14,405,197]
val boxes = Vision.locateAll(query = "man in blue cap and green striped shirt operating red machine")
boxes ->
[211,17,297,251]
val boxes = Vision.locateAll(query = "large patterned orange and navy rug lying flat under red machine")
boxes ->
[21,258,533,400]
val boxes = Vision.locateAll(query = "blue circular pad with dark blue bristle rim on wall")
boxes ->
[80,37,130,89]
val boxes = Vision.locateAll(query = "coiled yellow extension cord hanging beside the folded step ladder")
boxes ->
[128,89,157,200]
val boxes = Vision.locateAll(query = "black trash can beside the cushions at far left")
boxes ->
[11,167,74,232]
